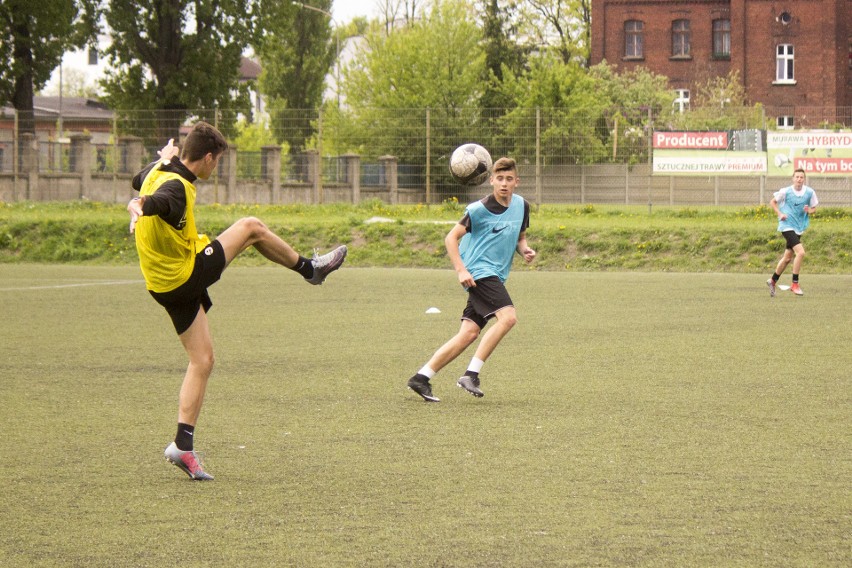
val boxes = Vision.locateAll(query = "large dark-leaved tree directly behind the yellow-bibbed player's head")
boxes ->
[102,0,256,141]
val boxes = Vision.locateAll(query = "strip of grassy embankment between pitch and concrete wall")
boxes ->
[0,201,852,274]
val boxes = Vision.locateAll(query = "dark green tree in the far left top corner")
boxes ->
[0,0,99,133]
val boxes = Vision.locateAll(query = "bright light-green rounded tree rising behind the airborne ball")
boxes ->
[339,0,485,164]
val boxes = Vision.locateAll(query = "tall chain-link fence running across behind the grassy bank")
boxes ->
[0,107,852,206]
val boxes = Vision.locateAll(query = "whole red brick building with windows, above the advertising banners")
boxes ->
[591,0,852,128]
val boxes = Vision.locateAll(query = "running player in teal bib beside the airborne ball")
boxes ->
[408,158,535,402]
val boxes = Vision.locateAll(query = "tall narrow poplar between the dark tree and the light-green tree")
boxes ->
[255,0,332,150]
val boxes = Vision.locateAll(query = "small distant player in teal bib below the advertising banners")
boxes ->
[766,169,819,297]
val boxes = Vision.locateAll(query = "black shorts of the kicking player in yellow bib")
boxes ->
[149,241,225,335]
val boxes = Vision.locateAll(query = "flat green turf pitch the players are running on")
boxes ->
[0,264,852,567]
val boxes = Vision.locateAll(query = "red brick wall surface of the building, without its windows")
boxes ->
[591,0,852,117]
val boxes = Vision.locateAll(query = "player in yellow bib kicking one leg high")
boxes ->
[127,122,346,480]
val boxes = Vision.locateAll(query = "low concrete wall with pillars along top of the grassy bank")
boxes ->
[0,135,852,207]
